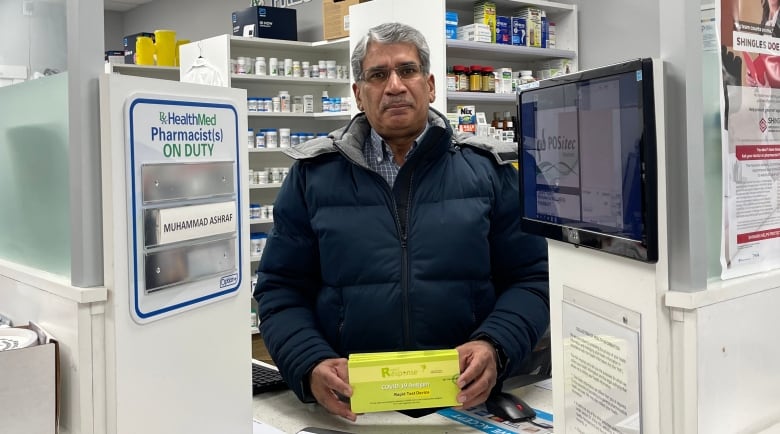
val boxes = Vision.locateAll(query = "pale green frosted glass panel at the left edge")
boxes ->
[0,73,70,278]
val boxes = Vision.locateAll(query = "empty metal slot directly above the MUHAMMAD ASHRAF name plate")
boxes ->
[141,161,236,204]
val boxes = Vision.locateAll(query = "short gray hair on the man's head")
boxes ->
[350,23,431,81]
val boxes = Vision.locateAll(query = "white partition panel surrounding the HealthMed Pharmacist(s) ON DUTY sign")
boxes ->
[100,74,252,434]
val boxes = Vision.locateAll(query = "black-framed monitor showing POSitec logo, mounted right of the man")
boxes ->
[518,59,658,262]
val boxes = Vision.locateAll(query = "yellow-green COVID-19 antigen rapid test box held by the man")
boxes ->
[347,349,460,413]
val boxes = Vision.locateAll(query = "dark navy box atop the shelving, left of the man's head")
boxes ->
[231,6,298,41]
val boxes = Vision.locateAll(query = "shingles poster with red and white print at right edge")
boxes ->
[719,0,780,279]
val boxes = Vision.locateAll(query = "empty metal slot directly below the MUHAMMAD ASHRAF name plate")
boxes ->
[144,236,237,293]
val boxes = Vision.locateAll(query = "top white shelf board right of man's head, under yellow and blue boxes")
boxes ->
[447,39,577,62]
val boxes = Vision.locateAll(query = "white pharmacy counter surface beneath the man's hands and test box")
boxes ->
[253,378,552,434]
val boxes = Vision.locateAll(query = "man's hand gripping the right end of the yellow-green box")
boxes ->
[456,340,498,408]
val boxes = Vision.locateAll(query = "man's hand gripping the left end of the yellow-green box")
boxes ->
[309,359,357,422]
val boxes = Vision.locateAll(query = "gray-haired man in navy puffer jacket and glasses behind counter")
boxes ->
[255,23,549,421]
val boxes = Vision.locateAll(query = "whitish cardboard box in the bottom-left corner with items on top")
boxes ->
[0,323,59,434]
